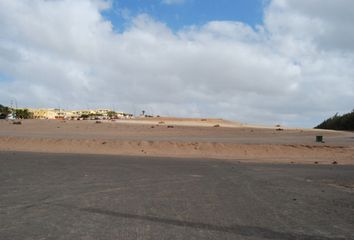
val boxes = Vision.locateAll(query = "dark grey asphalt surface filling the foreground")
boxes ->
[0,152,354,240]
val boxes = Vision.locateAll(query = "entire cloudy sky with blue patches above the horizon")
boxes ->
[0,0,354,127]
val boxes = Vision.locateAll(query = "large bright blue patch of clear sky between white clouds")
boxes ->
[104,0,264,31]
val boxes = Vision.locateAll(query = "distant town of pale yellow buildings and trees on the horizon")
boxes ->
[0,105,134,120]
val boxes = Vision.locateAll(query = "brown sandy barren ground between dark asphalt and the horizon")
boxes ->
[0,118,354,164]
